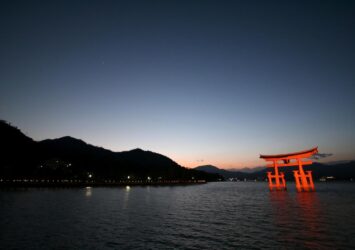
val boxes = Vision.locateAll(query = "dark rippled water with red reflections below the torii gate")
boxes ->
[0,182,355,249]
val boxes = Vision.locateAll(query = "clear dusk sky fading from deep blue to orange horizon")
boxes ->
[0,0,355,168]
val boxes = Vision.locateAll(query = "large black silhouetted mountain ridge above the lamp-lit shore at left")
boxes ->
[0,121,221,180]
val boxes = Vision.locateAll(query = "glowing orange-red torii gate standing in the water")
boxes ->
[260,147,318,192]
